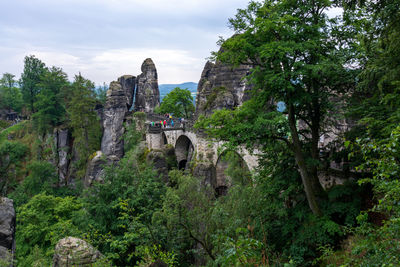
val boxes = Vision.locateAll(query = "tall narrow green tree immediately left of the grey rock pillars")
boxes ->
[67,74,101,175]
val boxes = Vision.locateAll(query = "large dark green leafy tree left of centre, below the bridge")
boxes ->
[80,141,165,266]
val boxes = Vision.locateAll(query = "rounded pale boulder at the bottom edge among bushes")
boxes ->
[53,237,101,267]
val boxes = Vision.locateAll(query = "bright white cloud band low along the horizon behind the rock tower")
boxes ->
[7,48,205,85]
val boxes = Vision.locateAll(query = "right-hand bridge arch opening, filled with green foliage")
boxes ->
[215,150,251,197]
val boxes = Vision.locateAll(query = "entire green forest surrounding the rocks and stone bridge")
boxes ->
[0,0,400,267]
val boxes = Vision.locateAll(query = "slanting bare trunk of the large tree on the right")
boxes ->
[288,104,322,216]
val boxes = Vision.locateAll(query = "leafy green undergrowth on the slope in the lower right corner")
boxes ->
[323,124,400,266]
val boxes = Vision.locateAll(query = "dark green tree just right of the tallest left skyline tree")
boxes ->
[32,67,69,134]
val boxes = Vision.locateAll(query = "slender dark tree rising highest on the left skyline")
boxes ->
[20,55,47,113]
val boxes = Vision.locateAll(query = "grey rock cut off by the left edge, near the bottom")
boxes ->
[0,197,15,265]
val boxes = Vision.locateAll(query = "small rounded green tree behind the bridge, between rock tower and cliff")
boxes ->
[157,87,194,118]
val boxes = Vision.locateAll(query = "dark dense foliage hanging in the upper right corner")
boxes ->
[345,0,400,139]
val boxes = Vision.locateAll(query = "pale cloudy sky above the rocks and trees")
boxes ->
[0,0,252,85]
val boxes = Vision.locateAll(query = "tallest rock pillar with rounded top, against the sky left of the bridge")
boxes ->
[135,58,160,113]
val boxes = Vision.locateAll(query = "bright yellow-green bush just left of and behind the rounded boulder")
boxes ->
[16,193,82,266]
